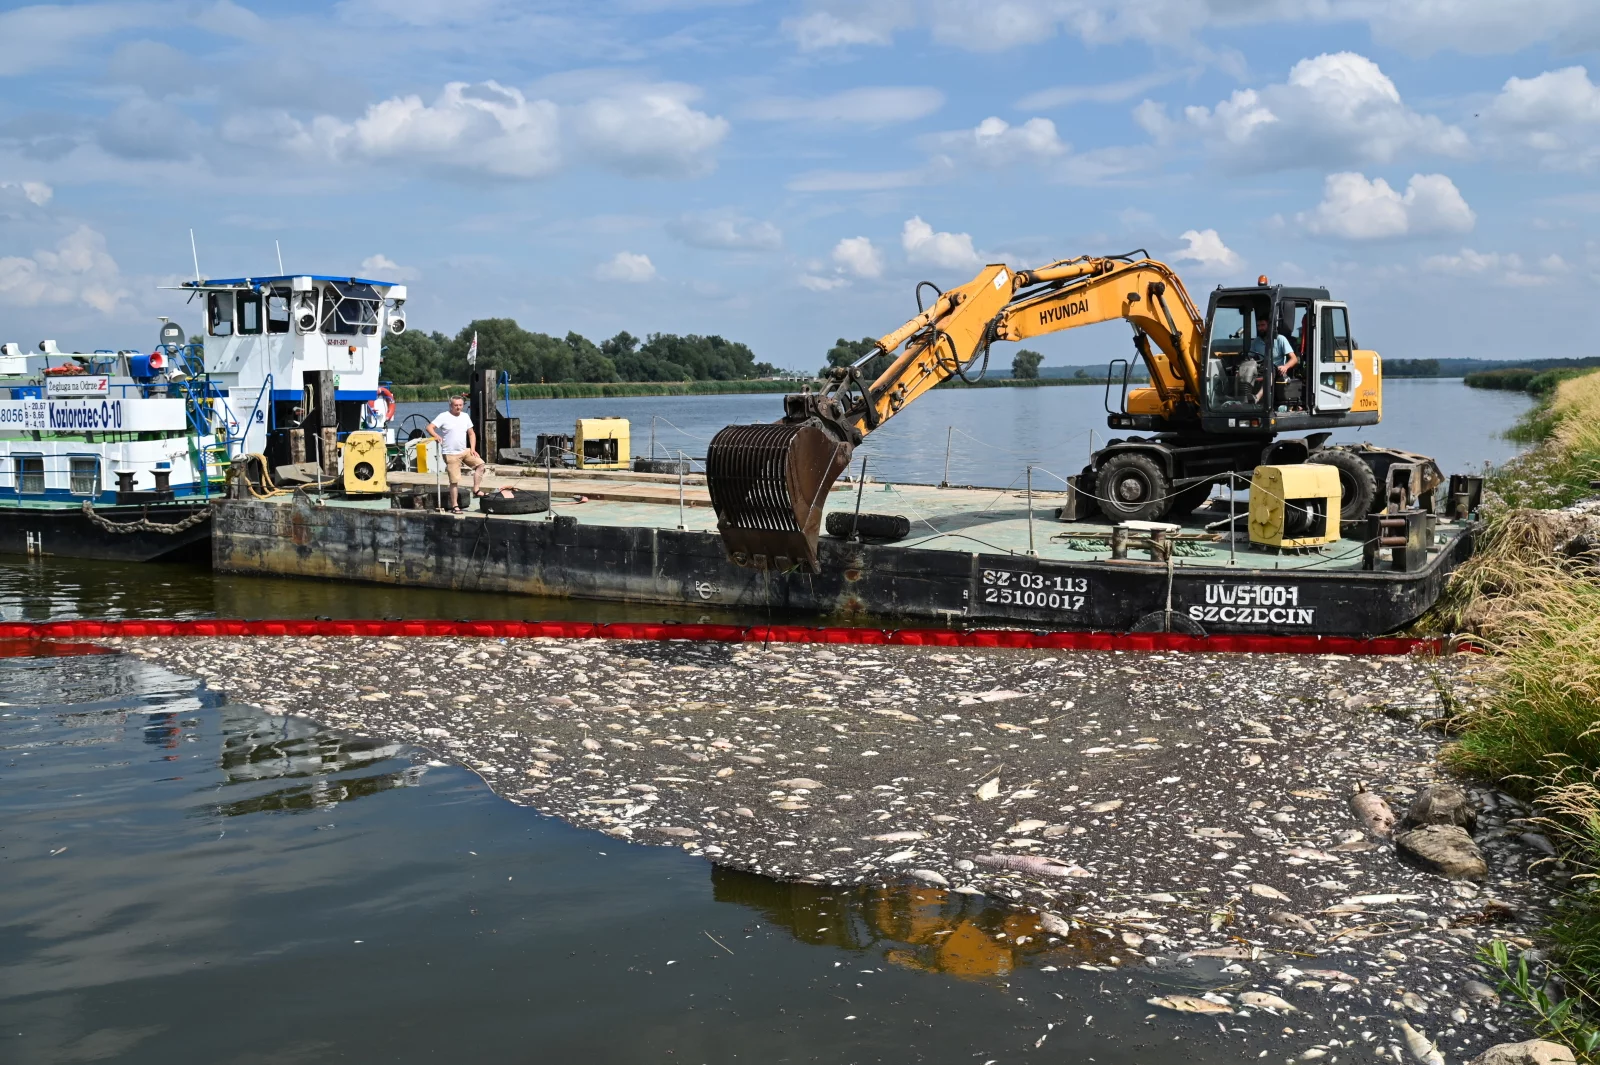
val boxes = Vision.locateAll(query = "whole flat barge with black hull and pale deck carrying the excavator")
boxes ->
[213,467,1474,636]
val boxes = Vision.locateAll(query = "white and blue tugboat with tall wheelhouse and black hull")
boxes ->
[0,275,406,563]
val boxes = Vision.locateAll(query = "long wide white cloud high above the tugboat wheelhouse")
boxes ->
[222,82,728,179]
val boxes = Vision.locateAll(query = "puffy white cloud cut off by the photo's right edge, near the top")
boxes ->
[1485,67,1600,170]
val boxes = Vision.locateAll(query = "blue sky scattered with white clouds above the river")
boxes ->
[0,0,1600,369]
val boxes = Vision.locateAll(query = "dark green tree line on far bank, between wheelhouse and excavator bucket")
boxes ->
[384,318,779,384]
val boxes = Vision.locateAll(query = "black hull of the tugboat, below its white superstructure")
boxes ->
[0,501,211,563]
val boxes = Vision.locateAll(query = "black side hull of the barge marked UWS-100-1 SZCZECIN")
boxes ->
[213,497,1472,636]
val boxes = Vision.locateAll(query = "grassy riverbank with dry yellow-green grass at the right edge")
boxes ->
[1438,373,1600,1060]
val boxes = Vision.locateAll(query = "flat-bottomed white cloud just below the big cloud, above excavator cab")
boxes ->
[1294,173,1477,240]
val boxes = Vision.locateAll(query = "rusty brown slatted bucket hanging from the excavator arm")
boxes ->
[706,421,854,572]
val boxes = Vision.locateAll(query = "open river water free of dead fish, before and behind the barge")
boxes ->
[0,381,1525,1065]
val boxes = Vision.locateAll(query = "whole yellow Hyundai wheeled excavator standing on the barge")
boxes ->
[706,249,1416,571]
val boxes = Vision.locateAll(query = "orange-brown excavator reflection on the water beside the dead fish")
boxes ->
[710,867,1126,980]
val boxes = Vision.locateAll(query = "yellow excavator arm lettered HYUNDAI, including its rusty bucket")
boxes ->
[706,256,1203,571]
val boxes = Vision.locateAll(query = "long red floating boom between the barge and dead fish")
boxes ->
[0,619,1472,657]
